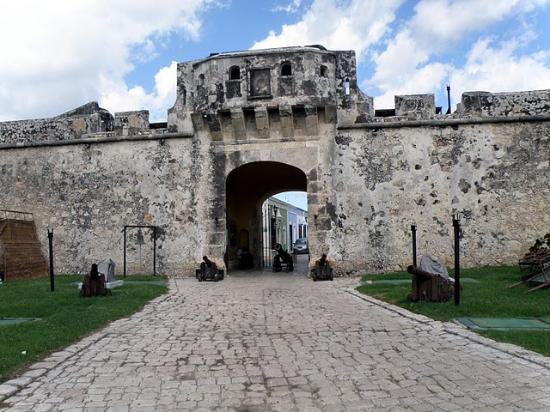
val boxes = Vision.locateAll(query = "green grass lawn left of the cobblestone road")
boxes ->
[0,275,167,382]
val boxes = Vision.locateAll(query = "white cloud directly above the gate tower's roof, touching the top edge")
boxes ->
[252,0,403,59]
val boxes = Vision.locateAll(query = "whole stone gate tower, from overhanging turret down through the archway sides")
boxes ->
[164,46,373,270]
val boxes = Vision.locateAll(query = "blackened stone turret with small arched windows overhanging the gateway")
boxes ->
[168,45,373,134]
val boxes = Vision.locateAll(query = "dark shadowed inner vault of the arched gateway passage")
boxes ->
[225,161,307,271]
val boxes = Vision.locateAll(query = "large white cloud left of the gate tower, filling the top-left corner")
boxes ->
[0,0,220,121]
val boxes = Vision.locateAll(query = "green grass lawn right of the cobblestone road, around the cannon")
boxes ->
[357,266,550,356]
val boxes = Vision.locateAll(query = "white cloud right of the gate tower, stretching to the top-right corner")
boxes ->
[363,0,550,107]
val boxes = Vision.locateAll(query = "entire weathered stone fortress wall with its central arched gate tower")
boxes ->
[0,46,550,275]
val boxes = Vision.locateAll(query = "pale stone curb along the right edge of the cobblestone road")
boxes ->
[344,288,550,370]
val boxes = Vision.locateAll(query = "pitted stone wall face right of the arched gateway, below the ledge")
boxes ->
[327,121,550,271]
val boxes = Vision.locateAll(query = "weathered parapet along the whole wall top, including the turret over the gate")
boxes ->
[0,45,550,145]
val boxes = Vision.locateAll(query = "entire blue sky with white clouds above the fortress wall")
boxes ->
[0,0,550,206]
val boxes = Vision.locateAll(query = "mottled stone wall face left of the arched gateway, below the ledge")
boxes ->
[0,138,208,274]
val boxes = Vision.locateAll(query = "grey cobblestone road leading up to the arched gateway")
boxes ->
[0,273,550,412]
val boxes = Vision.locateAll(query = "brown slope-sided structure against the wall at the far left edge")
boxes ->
[0,210,48,280]
